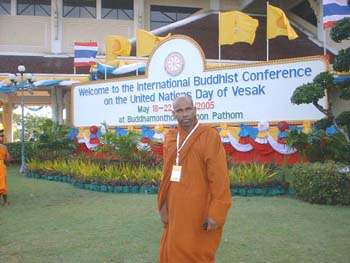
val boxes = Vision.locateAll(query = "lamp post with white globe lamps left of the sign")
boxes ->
[9,65,34,173]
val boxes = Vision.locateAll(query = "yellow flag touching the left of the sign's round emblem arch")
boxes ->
[136,29,171,57]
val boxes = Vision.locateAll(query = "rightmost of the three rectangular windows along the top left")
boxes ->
[101,0,134,20]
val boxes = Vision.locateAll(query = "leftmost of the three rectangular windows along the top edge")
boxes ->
[17,0,51,16]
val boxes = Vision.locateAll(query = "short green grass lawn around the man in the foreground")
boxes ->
[0,166,350,263]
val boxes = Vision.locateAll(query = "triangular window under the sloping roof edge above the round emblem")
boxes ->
[151,5,200,30]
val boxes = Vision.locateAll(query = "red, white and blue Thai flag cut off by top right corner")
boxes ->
[323,0,350,28]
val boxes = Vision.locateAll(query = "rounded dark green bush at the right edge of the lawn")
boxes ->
[292,161,350,205]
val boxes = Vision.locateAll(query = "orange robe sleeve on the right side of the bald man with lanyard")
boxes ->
[206,129,232,226]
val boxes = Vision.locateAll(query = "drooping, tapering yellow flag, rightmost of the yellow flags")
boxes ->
[266,4,298,40]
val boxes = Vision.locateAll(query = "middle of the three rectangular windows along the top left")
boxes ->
[63,0,96,18]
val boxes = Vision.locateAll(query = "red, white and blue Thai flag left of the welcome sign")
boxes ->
[74,42,98,67]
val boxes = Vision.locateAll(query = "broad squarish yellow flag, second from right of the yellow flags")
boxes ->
[219,11,259,45]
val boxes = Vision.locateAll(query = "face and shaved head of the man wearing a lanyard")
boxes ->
[173,97,196,132]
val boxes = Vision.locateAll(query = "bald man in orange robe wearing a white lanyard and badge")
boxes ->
[158,95,232,263]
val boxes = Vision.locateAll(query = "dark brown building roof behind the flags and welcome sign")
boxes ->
[0,14,334,74]
